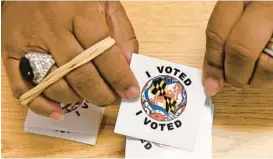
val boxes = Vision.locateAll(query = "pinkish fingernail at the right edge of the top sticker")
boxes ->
[205,77,220,97]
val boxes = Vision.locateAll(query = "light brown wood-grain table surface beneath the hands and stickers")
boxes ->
[1,2,273,158]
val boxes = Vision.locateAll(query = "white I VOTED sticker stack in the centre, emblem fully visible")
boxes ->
[115,55,214,159]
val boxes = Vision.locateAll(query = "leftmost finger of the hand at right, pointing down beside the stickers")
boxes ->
[203,1,244,96]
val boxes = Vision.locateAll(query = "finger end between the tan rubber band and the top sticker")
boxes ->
[94,45,139,99]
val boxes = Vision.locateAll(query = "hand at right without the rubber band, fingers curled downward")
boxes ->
[203,2,273,96]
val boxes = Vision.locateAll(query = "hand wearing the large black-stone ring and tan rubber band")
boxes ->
[2,2,139,120]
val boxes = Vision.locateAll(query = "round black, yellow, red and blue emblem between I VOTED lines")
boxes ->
[141,75,187,121]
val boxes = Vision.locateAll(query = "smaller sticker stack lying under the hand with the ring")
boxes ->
[24,101,104,145]
